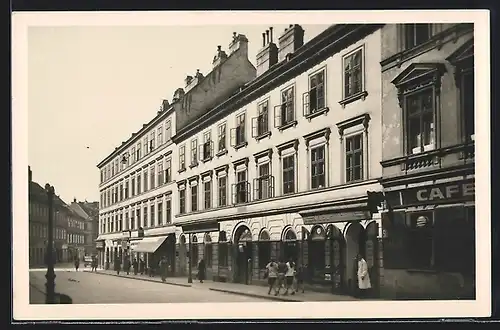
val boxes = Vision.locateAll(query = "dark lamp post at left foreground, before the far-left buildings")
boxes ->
[45,183,56,304]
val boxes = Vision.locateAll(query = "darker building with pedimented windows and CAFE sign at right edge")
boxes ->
[381,23,475,298]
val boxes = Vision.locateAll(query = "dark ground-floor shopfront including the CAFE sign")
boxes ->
[382,178,475,299]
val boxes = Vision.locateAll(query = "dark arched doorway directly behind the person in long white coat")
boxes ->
[345,221,365,294]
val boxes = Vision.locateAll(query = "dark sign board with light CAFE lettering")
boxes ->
[386,179,475,207]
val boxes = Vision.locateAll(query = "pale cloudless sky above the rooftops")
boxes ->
[28,24,328,203]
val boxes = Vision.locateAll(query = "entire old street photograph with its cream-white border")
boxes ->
[12,10,491,320]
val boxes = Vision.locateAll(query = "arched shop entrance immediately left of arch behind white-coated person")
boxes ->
[325,225,345,292]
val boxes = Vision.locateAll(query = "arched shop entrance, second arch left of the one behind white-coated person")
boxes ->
[308,225,326,281]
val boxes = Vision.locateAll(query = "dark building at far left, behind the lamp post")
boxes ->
[28,167,68,267]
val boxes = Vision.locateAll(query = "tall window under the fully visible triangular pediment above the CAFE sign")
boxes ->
[406,88,434,154]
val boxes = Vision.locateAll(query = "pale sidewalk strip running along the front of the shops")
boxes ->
[84,269,358,302]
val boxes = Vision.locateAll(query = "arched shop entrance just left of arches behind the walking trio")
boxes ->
[234,226,252,284]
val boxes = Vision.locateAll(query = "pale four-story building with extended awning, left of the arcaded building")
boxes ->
[96,99,178,271]
